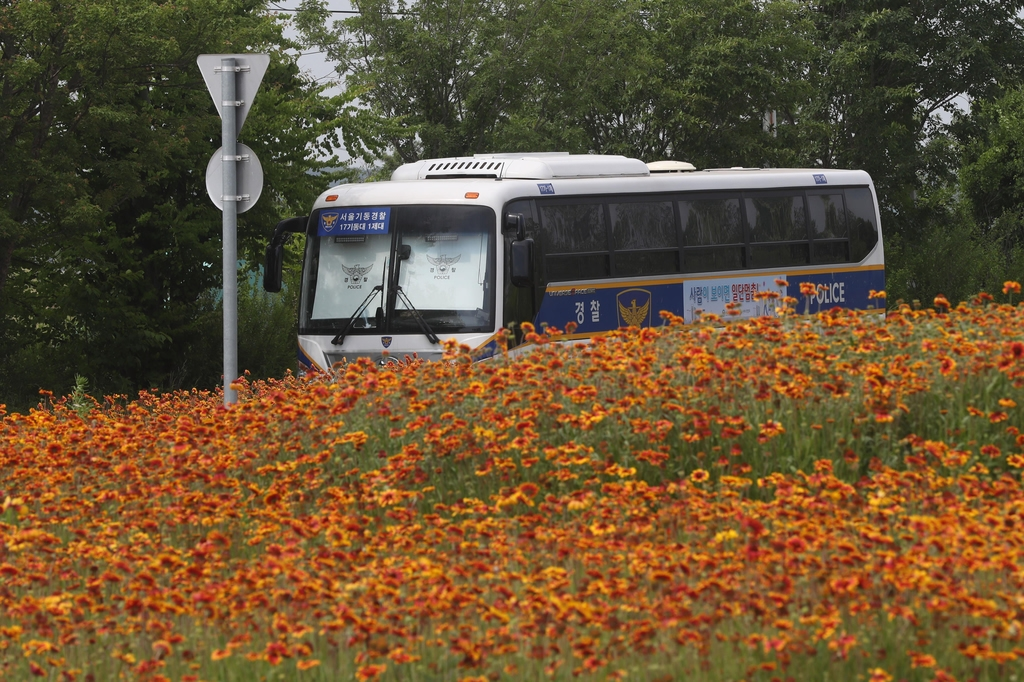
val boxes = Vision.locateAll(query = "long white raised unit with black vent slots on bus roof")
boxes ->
[391,152,650,180]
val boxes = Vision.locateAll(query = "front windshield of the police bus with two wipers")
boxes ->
[300,206,497,335]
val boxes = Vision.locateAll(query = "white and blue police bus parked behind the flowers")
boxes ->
[264,154,885,370]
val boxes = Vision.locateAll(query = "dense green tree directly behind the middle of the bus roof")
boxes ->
[526,0,812,167]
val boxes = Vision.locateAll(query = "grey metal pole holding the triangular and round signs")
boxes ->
[220,57,239,408]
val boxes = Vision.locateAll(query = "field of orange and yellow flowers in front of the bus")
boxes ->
[0,283,1024,682]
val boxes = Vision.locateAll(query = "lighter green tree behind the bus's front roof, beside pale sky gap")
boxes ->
[297,0,537,162]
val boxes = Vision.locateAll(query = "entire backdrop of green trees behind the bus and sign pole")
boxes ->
[6,0,1024,409]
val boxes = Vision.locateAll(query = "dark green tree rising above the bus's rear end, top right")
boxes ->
[801,0,1024,216]
